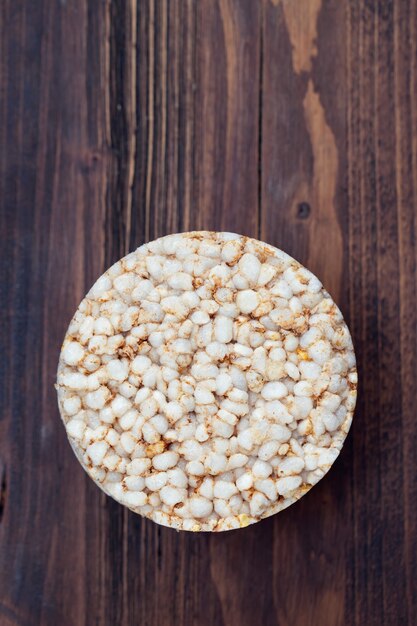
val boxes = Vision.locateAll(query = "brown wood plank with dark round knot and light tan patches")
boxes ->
[261,0,352,626]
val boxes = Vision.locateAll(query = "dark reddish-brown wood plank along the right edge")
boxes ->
[348,1,417,624]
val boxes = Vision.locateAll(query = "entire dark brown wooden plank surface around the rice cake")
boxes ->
[0,0,417,626]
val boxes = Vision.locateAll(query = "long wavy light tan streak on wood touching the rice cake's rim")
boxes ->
[303,79,343,299]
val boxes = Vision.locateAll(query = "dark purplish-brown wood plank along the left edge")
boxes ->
[0,1,108,625]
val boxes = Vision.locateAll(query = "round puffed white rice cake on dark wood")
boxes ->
[57,231,357,531]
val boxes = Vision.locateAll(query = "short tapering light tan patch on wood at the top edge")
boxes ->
[282,0,322,74]
